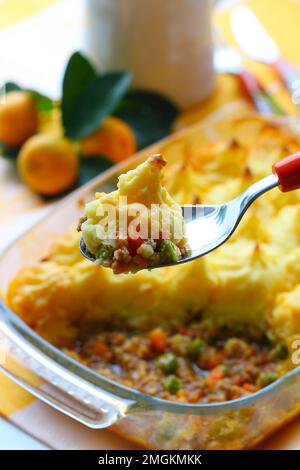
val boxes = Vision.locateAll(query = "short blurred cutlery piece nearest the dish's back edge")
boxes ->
[239,69,283,115]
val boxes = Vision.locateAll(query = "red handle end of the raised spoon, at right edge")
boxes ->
[272,152,300,193]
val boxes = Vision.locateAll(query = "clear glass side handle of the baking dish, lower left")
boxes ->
[0,309,134,429]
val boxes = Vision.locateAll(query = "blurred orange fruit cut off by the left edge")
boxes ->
[0,91,38,147]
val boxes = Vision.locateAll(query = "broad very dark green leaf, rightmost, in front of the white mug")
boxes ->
[114,90,179,148]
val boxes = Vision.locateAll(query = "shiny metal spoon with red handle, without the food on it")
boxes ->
[80,152,300,269]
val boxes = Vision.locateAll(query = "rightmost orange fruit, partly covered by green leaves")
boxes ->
[80,116,136,162]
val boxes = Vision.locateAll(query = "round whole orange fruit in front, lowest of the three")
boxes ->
[17,134,79,196]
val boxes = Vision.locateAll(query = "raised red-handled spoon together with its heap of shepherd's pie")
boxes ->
[79,152,300,273]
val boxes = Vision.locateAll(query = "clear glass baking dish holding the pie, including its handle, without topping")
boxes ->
[0,117,300,449]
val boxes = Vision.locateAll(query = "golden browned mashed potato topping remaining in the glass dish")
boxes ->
[8,121,300,352]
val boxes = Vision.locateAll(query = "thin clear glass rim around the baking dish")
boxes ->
[0,135,300,415]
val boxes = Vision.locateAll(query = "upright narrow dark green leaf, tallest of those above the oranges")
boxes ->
[62,52,96,134]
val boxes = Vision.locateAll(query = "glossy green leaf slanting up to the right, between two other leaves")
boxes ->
[64,71,131,139]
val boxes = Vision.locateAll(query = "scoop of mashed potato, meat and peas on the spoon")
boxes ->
[79,154,187,274]
